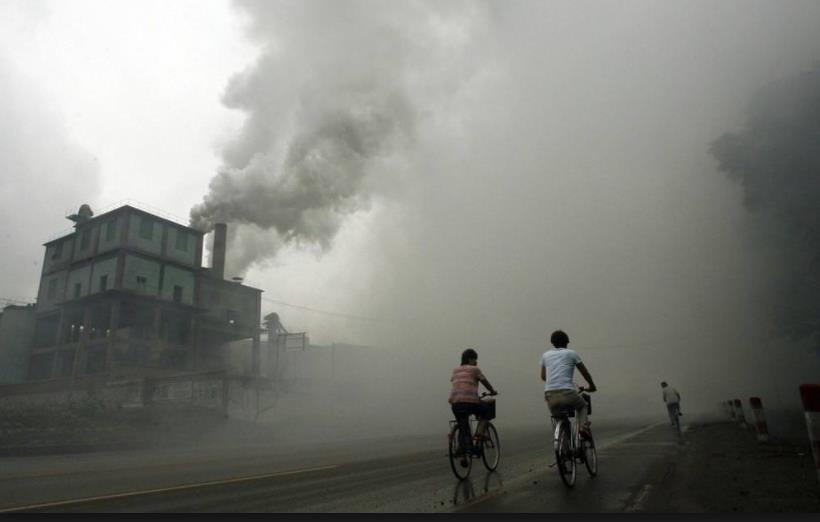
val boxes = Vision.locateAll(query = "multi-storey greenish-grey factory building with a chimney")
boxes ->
[27,205,262,380]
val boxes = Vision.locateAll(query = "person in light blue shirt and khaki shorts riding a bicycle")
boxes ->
[541,330,597,437]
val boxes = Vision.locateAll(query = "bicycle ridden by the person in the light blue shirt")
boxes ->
[551,387,598,488]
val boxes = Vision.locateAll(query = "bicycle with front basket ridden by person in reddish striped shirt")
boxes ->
[447,392,501,480]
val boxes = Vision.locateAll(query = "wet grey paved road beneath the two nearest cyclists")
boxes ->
[0,422,678,513]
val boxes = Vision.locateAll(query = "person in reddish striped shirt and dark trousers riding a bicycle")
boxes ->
[448,348,498,466]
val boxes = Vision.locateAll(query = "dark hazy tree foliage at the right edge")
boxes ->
[711,65,820,348]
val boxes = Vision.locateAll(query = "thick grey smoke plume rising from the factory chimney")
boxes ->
[191,1,490,272]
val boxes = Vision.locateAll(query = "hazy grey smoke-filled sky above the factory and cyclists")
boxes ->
[0,0,820,414]
